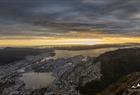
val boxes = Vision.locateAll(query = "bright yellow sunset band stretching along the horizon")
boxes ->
[0,37,140,47]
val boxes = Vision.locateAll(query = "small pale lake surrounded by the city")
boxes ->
[21,72,55,89]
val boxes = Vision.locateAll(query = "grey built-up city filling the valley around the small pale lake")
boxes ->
[0,53,101,95]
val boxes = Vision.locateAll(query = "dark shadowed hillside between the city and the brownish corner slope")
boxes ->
[80,48,140,95]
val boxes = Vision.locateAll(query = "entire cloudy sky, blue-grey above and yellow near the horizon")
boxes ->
[0,0,140,45]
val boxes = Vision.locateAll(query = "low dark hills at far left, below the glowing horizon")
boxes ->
[0,47,53,65]
